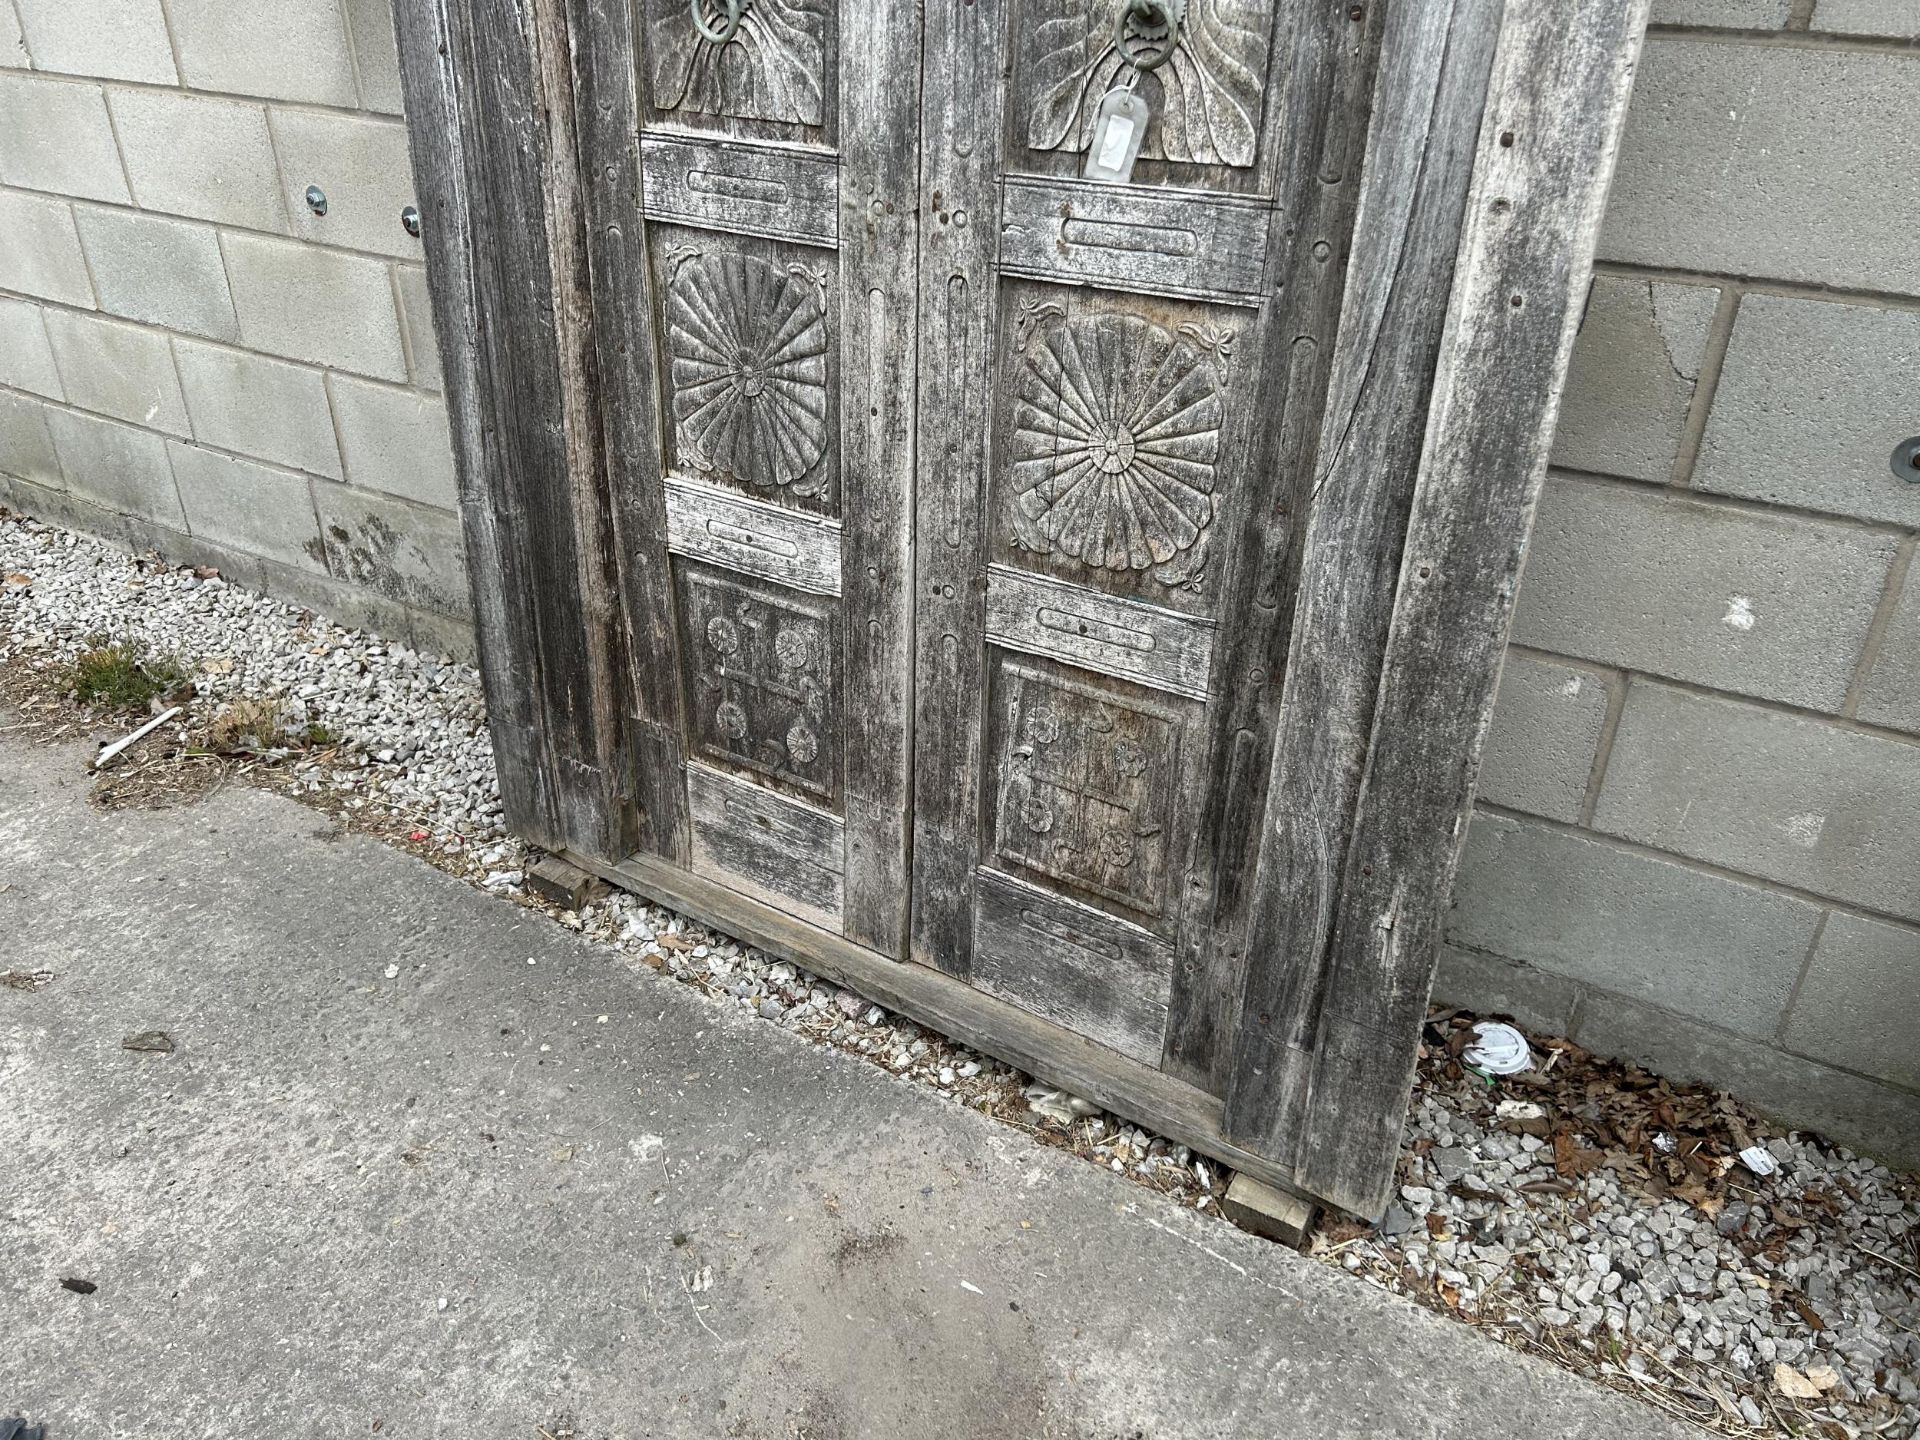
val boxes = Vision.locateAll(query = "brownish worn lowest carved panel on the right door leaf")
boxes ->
[993,655,1183,920]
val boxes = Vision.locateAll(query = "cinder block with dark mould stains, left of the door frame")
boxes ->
[313,484,470,616]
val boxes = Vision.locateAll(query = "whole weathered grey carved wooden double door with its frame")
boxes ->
[396,0,1645,1213]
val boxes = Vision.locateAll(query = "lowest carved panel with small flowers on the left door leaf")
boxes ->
[676,561,841,806]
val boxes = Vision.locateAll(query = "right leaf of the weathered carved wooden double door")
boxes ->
[912,0,1371,1094]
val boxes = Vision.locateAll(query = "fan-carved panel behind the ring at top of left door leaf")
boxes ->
[647,0,828,127]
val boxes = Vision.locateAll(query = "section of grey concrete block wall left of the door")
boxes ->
[0,0,472,653]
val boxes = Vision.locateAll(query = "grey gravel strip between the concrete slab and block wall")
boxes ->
[0,511,1920,1440]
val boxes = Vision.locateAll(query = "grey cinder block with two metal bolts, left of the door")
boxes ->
[273,109,420,259]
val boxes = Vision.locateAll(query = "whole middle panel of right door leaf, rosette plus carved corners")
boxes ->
[993,292,1235,609]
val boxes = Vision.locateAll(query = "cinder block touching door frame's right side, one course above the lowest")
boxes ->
[1448,814,1820,1037]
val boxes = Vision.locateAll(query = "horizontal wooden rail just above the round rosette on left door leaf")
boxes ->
[639,134,839,248]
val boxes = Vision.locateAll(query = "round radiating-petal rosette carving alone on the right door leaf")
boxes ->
[1012,305,1225,586]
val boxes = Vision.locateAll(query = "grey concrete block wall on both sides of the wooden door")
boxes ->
[0,0,1920,1162]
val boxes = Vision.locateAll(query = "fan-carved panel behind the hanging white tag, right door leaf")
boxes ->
[1027,0,1273,169]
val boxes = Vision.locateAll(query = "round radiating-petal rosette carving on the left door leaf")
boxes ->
[666,252,829,495]
